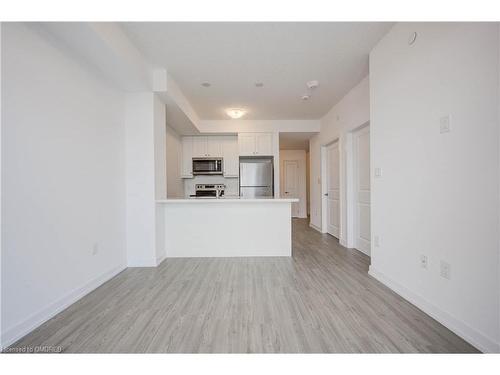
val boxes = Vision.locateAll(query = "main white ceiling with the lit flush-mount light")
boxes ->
[122,22,392,120]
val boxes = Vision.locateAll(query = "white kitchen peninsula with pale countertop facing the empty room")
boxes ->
[157,197,298,258]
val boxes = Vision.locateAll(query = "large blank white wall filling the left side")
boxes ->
[0,23,126,346]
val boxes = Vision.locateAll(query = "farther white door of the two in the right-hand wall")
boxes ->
[326,142,340,238]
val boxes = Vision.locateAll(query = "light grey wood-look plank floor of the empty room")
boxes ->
[9,219,476,353]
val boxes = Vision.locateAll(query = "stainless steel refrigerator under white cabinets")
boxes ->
[240,157,274,198]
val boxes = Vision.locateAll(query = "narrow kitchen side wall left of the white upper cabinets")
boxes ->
[166,126,184,198]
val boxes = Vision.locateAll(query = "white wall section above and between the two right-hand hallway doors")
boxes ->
[309,77,370,246]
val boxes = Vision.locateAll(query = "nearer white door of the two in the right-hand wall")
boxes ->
[353,126,370,255]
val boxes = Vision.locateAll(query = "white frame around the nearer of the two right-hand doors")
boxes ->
[341,121,371,253]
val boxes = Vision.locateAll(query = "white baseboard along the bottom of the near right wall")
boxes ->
[368,266,500,353]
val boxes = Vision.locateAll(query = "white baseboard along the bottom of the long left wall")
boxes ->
[0,265,127,349]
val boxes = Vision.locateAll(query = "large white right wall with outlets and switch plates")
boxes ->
[370,23,500,351]
